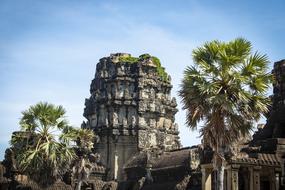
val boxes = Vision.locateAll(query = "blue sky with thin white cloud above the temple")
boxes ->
[0,0,285,159]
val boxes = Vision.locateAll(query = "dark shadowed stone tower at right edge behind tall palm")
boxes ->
[250,60,285,154]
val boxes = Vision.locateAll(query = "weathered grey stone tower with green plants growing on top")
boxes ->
[83,53,181,180]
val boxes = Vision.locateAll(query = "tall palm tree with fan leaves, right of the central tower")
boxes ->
[179,38,271,190]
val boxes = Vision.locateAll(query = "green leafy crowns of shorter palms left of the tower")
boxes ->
[11,102,95,185]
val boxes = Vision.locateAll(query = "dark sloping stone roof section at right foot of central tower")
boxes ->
[121,146,202,190]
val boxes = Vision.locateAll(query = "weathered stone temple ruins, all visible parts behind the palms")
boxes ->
[0,53,285,190]
